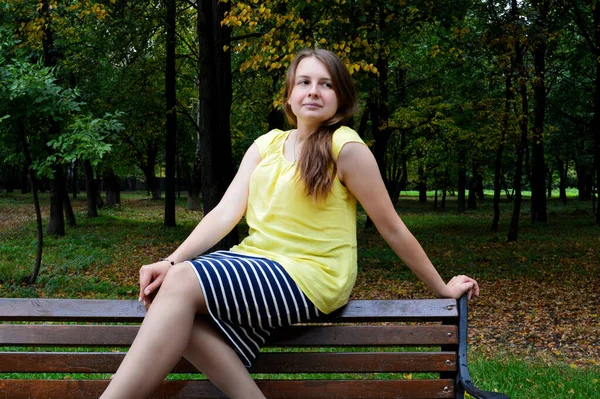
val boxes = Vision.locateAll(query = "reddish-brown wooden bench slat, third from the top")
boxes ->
[0,352,456,373]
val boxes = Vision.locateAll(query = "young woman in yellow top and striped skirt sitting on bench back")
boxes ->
[102,49,479,399]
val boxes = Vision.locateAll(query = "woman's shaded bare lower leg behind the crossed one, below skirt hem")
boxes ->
[184,317,265,399]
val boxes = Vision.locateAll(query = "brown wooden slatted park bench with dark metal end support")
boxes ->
[0,297,508,399]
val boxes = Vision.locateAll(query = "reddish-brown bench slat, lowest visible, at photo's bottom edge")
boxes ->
[0,380,455,399]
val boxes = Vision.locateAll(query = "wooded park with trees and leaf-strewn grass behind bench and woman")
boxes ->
[0,0,600,398]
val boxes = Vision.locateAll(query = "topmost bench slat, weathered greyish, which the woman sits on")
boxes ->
[0,298,458,322]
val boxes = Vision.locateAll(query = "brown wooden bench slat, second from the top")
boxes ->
[0,324,458,347]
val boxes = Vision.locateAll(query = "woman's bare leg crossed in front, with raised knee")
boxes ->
[101,263,207,399]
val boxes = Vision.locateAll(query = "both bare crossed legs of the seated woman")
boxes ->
[102,263,264,399]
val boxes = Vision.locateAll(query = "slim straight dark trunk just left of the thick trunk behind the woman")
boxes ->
[164,0,177,227]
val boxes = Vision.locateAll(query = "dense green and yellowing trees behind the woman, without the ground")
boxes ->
[0,0,600,256]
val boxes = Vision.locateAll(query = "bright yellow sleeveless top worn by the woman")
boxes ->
[231,127,363,313]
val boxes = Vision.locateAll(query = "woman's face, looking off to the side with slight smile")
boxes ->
[288,57,338,126]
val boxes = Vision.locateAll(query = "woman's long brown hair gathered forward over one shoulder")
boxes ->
[283,49,358,200]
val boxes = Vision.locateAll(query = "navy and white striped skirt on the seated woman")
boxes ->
[190,251,321,367]
